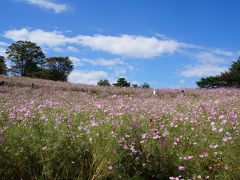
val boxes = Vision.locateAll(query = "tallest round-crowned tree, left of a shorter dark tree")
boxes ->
[6,41,45,77]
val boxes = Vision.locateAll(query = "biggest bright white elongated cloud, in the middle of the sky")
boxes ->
[75,35,188,58]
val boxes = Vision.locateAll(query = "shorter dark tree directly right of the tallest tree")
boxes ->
[46,57,73,81]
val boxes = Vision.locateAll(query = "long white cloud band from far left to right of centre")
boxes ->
[4,28,192,58]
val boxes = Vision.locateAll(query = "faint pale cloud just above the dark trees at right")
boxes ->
[180,64,228,77]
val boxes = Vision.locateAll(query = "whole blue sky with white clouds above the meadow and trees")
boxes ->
[0,0,240,88]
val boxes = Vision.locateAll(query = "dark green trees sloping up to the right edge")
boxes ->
[196,58,240,88]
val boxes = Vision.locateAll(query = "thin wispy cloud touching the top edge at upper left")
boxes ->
[22,0,70,14]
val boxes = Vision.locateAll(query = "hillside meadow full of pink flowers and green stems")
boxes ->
[0,76,240,180]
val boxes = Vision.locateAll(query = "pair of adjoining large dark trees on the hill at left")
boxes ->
[6,41,73,81]
